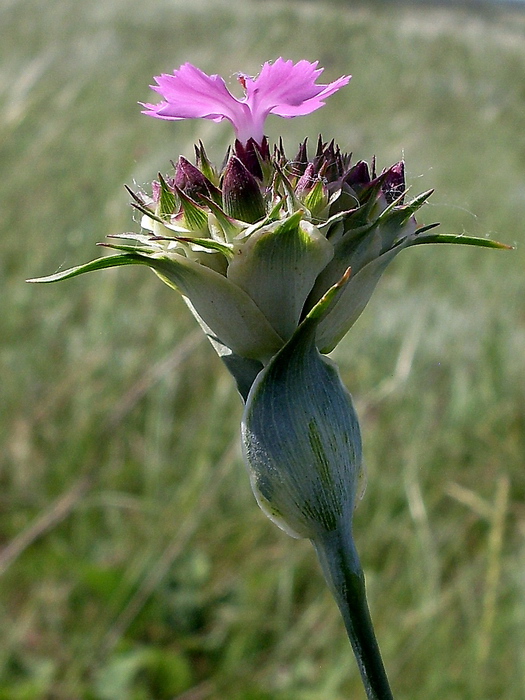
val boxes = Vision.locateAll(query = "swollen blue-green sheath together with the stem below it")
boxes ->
[242,272,392,700]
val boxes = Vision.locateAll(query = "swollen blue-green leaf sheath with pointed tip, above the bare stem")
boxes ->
[242,273,362,541]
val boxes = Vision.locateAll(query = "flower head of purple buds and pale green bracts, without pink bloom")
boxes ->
[30,139,506,388]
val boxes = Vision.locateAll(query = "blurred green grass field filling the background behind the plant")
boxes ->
[0,0,525,700]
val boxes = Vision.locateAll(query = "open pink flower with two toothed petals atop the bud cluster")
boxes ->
[141,58,351,143]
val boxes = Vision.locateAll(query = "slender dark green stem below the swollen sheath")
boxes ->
[312,525,393,700]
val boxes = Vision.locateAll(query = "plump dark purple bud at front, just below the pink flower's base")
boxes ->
[222,156,266,224]
